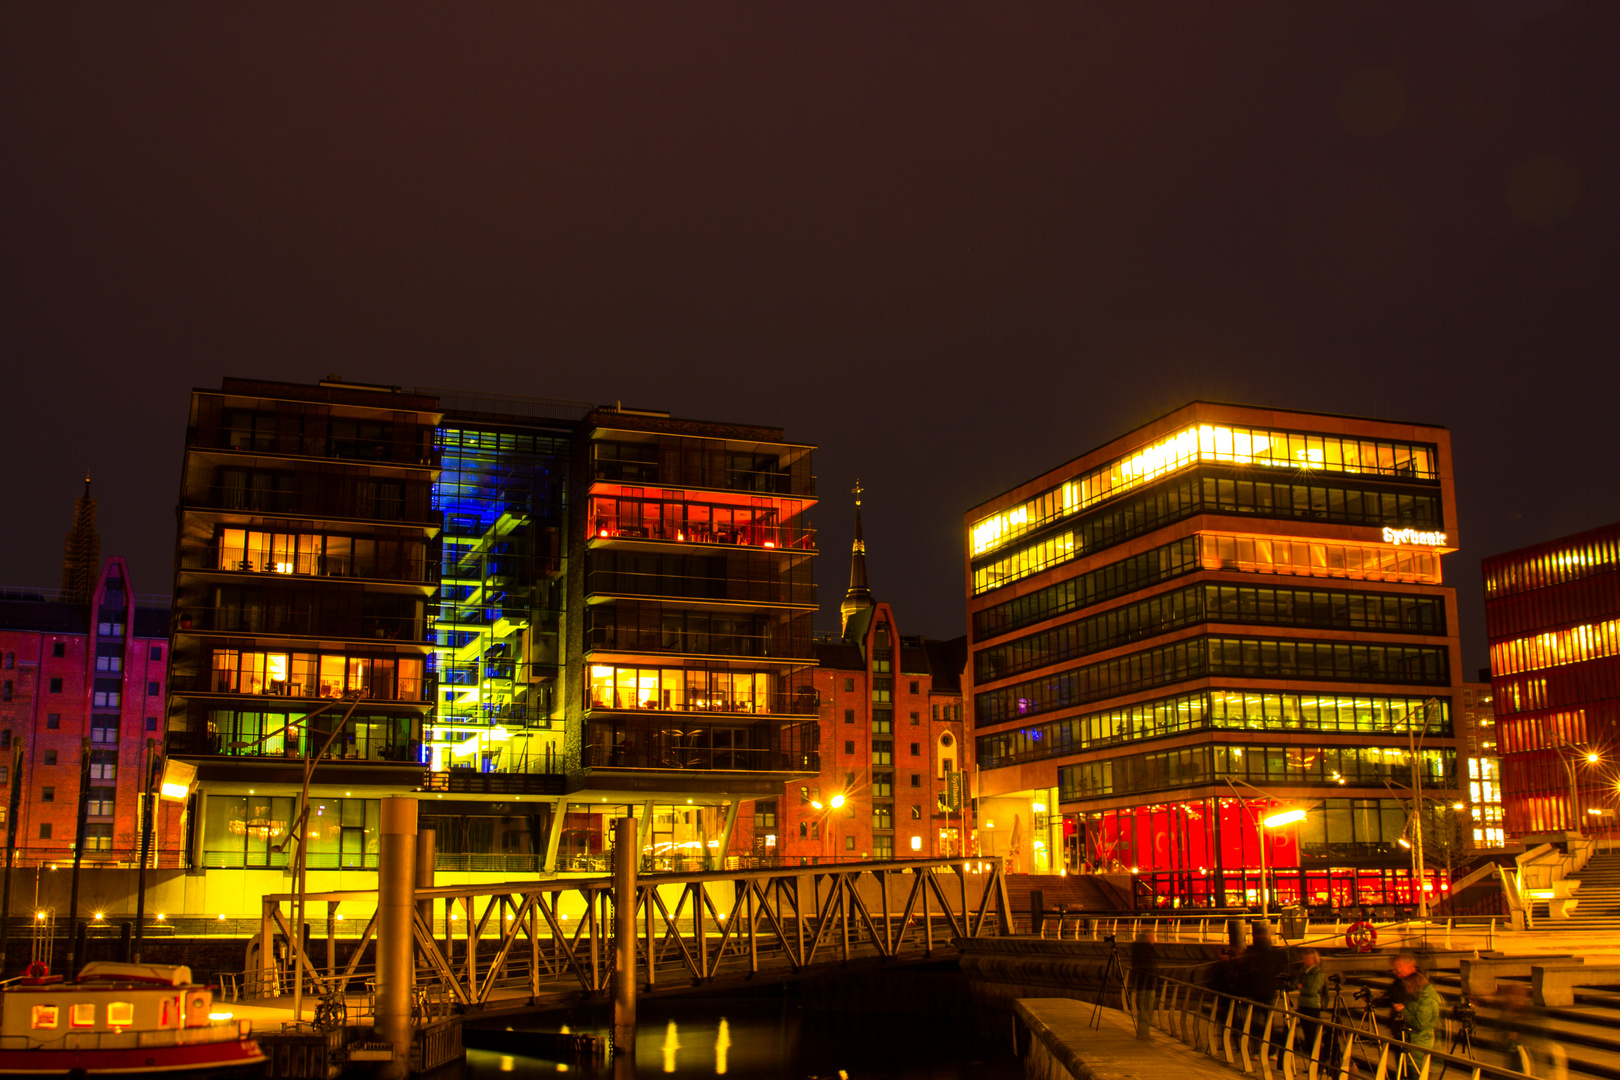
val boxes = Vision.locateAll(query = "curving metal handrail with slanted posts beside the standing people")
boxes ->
[1127,975,1529,1080]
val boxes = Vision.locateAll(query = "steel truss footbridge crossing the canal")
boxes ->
[241,858,1011,1020]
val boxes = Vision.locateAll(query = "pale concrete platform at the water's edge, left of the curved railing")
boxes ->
[1013,997,1234,1080]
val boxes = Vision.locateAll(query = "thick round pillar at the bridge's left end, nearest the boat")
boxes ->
[376,797,416,1080]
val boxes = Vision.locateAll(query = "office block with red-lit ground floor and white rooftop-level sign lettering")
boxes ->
[966,402,1461,907]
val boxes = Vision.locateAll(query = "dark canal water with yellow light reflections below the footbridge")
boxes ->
[462,994,1022,1080]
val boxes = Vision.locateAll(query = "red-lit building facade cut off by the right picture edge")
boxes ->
[1484,523,1620,839]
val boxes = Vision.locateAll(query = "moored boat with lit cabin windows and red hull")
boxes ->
[0,962,264,1080]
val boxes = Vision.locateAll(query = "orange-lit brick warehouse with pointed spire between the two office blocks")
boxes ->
[774,484,972,861]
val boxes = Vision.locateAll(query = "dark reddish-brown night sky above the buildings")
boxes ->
[0,0,1620,675]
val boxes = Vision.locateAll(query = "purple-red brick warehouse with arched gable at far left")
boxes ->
[0,555,183,866]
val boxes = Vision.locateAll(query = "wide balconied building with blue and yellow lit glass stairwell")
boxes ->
[167,377,818,893]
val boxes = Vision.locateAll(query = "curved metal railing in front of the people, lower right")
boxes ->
[1102,975,1529,1080]
